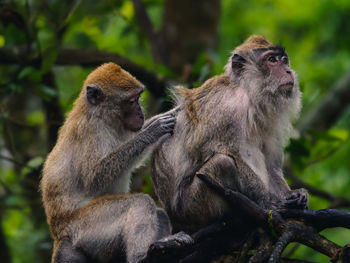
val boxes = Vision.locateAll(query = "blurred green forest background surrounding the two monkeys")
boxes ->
[0,0,350,263]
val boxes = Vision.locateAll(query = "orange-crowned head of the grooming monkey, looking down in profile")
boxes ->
[79,63,144,131]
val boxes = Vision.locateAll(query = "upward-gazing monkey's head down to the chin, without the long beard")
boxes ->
[225,35,299,99]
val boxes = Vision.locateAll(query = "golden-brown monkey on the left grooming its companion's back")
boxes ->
[40,63,192,263]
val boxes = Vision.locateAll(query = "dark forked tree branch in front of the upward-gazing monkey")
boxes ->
[197,174,350,263]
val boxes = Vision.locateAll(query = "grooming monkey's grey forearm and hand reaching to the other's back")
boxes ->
[84,114,175,193]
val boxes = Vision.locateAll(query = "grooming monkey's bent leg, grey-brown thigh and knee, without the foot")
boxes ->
[71,194,190,263]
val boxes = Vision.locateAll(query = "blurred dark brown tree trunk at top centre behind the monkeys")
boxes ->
[162,0,221,73]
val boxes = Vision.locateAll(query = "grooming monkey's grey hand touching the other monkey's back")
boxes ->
[142,112,176,140]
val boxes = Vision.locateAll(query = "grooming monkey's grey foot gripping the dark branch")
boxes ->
[145,232,194,262]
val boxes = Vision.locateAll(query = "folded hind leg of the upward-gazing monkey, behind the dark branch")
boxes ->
[174,153,275,224]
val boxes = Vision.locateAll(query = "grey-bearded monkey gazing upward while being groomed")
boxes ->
[151,35,308,233]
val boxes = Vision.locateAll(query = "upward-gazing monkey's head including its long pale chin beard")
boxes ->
[225,36,301,117]
